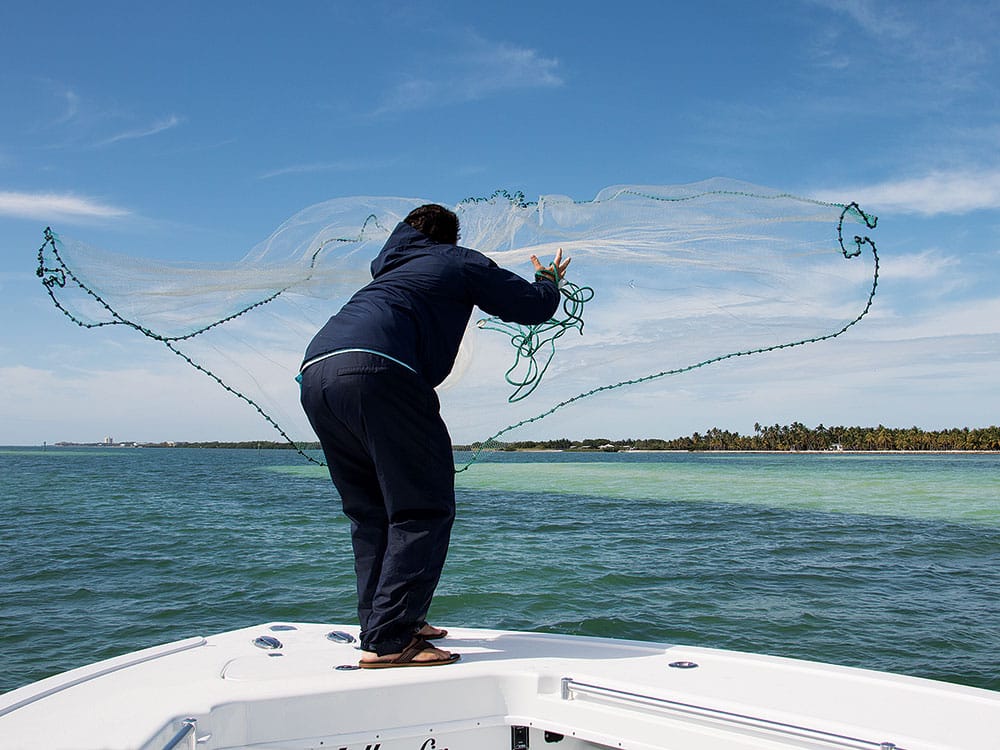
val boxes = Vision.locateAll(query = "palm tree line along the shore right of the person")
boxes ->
[455,422,1000,451]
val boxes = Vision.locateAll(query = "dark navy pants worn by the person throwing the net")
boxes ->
[302,352,455,656]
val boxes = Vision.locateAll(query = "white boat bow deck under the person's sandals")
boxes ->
[0,623,1000,750]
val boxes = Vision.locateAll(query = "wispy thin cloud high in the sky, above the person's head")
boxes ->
[375,32,563,114]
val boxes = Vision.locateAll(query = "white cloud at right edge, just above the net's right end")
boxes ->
[815,168,1000,216]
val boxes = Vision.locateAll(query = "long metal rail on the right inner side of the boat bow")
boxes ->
[561,677,906,750]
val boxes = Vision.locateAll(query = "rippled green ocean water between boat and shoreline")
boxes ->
[0,448,1000,691]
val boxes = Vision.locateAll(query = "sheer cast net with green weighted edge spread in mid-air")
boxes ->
[38,179,878,468]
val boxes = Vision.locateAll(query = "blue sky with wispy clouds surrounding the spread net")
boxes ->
[0,0,1000,444]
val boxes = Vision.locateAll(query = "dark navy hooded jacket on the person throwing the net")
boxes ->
[304,223,559,387]
